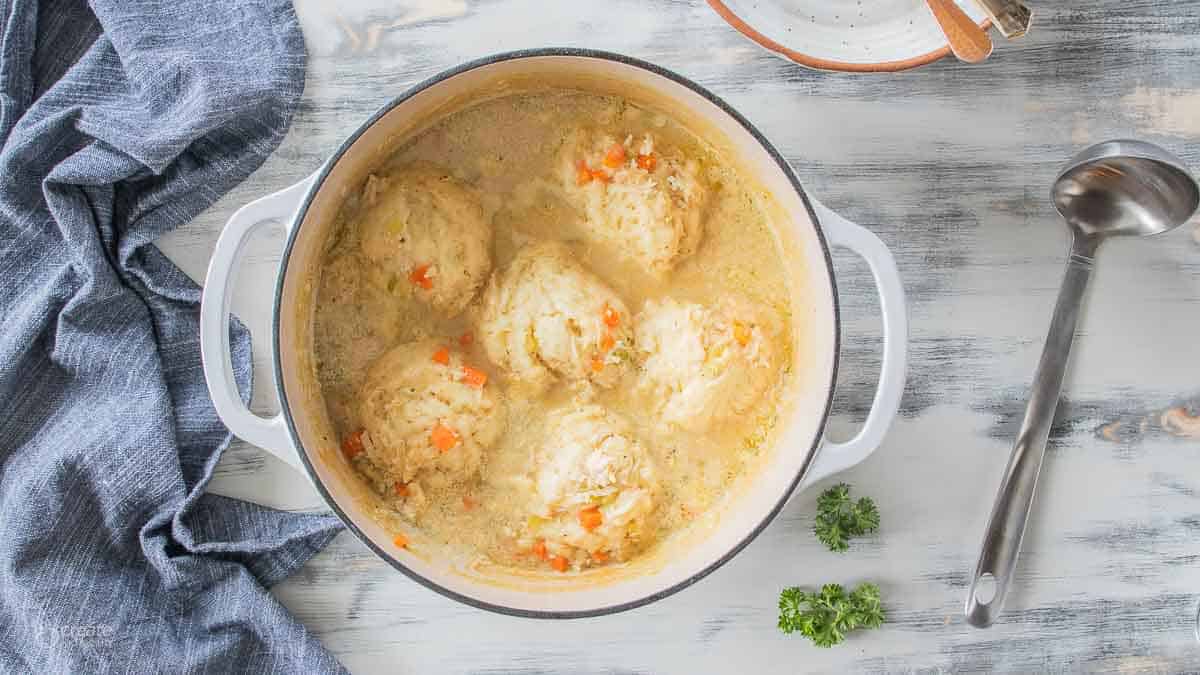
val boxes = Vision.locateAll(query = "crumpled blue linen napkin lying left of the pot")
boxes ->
[0,0,341,673]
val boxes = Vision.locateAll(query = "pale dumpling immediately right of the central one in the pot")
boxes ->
[635,297,780,430]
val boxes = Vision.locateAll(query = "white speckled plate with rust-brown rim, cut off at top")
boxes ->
[708,0,991,72]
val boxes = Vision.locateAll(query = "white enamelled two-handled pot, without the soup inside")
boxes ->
[200,49,907,617]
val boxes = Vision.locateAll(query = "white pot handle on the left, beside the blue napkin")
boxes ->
[200,174,316,472]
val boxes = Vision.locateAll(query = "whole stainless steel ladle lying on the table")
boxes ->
[965,141,1200,628]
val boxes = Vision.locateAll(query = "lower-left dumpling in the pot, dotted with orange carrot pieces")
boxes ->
[359,340,505,506]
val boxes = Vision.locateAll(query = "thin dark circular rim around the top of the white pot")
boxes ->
[271,47,841,619]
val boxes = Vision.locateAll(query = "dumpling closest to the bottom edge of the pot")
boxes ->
[527,404,658,566]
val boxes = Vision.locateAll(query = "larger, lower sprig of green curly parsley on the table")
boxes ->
[779,584,883,647]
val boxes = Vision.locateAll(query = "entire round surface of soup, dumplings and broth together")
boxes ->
[314,90,793,574]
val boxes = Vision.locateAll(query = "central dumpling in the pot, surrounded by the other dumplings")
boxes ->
[479,241,632,393]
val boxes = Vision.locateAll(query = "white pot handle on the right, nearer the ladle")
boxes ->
[803,199,908,486]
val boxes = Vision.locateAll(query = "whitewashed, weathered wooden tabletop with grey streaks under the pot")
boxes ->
[162,0,1200,673]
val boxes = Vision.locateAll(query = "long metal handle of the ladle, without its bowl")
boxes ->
[965,235,1097,628]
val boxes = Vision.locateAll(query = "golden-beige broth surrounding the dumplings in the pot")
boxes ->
[314,89,794,573]
